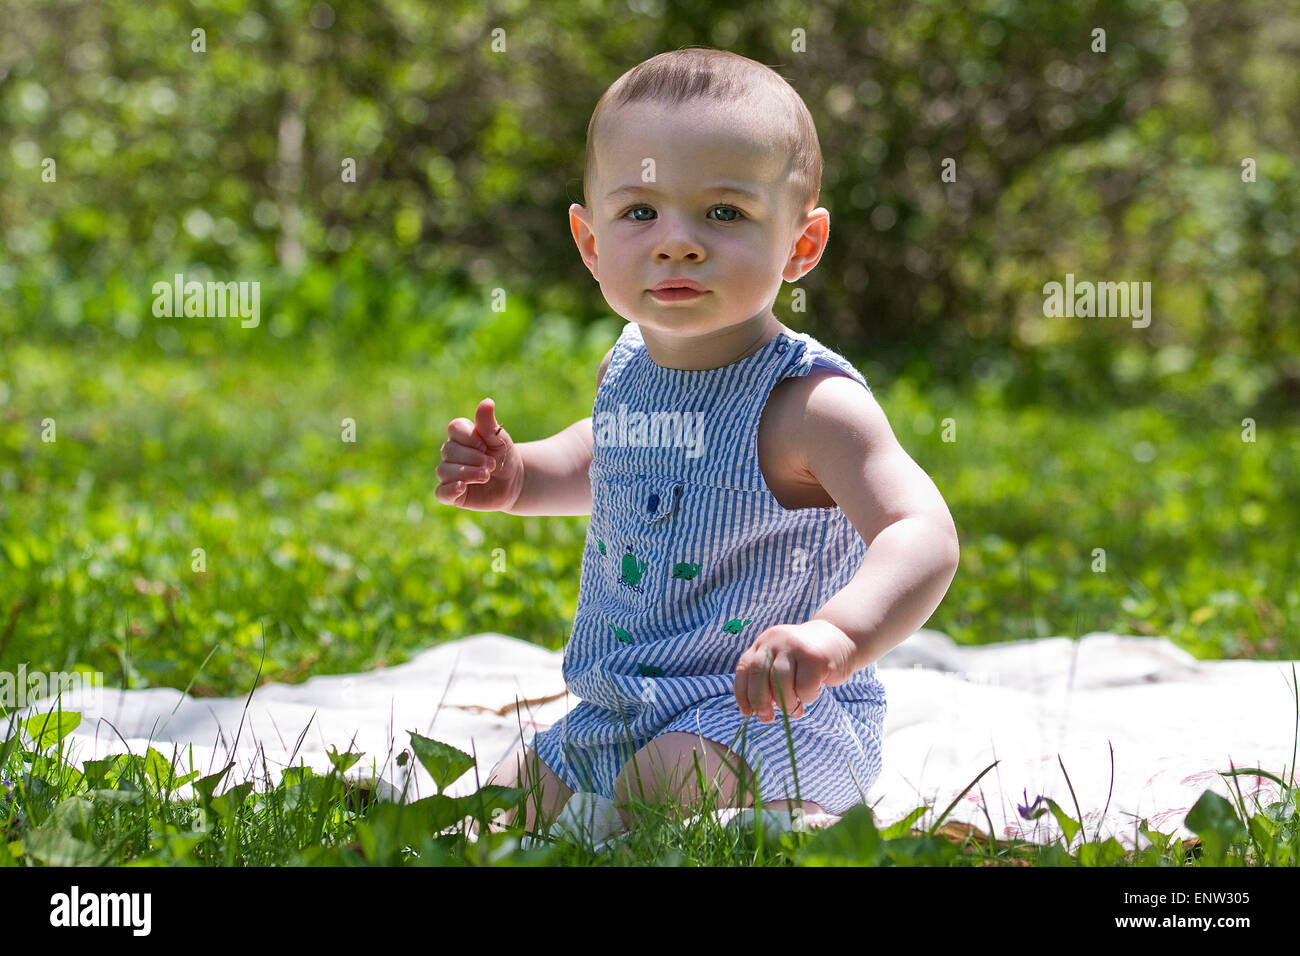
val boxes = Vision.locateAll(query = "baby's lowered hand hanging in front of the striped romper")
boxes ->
[736,619,858,723]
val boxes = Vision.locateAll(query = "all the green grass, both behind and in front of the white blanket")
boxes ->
[0,321,1300,865]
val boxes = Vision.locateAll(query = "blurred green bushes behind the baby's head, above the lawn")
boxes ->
[0,0,1300,412]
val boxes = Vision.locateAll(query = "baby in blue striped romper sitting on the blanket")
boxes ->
[437,48,958,830]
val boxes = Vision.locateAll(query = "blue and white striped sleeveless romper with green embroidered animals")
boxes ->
[532,323,885,813]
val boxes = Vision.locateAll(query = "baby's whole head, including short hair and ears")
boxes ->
[569,49,829,345]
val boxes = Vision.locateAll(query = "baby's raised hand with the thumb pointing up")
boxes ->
[434,398,524,511]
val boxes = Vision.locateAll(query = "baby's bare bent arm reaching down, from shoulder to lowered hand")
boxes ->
[736,373,959,719]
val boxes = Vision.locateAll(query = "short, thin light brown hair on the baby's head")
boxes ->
[582,47,822,226]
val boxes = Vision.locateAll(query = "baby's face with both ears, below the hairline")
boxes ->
[569,100,829,337]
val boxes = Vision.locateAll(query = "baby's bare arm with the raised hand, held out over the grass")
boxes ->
[437,349,614,515]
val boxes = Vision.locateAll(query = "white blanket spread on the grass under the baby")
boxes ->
[7,630,1296,848]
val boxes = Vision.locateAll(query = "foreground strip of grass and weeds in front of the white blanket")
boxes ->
[0,669,1300,866]
